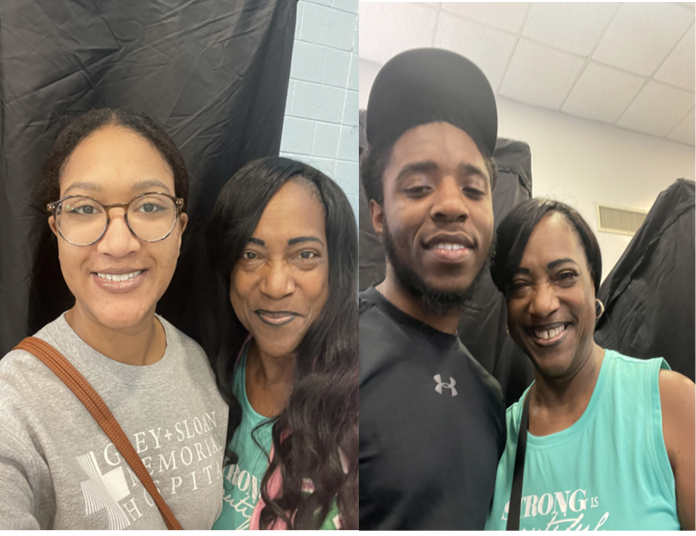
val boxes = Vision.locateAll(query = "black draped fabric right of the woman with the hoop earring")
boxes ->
[595,179,696,381]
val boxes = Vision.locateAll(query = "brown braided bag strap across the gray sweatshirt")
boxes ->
[14,337,182,530]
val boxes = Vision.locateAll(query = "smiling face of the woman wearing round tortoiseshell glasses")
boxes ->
[49,126,187,331]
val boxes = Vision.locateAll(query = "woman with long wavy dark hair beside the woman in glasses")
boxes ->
[202,158,359,529]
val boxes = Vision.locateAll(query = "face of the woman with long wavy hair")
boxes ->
[230,180,329,357]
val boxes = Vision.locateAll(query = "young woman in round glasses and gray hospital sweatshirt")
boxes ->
[0,109,228,529]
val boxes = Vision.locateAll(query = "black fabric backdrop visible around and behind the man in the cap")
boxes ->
[359,112,534,406]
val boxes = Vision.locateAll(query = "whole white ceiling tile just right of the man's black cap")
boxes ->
[500,39,584,110]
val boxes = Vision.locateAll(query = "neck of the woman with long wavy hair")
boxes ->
[244,339,295,417]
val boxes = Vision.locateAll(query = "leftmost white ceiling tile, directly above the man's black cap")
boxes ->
[359,2,438,63]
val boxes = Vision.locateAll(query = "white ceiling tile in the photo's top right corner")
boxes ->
[593,2,694,76]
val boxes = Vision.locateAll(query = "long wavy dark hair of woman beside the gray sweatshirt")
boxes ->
[201,157,359,530]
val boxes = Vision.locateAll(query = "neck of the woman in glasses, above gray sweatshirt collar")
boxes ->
[65,306,167,366]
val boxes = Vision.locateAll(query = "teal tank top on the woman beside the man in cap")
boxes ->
[486,350,680,530]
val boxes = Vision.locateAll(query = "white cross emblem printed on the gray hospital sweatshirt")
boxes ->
[77,452,130,530]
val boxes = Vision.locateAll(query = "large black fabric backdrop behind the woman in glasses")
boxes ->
[0,0,296,356]
